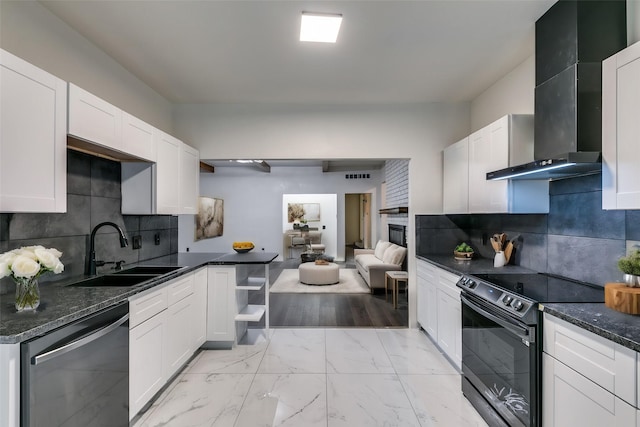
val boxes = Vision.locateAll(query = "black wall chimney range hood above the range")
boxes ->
[487,0,626,180]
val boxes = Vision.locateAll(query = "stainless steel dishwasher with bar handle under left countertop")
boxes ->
[21,303,129,427]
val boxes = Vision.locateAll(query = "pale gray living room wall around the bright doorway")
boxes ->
[178,167,383,260]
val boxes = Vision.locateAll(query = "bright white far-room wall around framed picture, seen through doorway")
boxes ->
[282,193,338,261]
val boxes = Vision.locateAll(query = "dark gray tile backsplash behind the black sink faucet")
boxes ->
[0,150,178,293]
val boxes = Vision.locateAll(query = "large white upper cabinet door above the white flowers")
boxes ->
[0,49,67,212]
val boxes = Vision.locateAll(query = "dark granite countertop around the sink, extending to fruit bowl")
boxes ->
[0,252,278,344]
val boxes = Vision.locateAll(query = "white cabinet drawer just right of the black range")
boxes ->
[543,313,637,406]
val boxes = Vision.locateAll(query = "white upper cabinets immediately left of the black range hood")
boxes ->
[443,114,549,213]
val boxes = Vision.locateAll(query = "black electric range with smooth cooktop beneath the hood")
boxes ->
[457,272,604,427]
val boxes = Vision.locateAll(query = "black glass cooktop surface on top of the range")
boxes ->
[473,273,604,304]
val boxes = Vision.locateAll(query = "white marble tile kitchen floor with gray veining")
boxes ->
[134,328,486,427]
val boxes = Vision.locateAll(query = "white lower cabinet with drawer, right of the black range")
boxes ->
[542,313,638,427]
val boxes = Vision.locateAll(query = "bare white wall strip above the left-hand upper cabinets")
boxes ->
[0,1,172,132]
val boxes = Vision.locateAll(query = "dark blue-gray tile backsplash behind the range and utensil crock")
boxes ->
[416,174,640,286]
